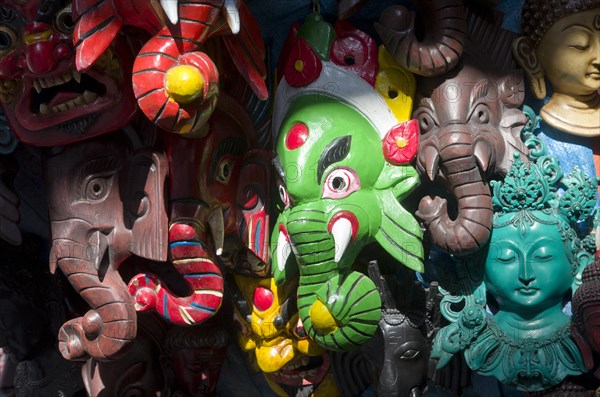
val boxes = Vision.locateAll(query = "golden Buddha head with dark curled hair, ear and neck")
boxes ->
[513,1,600,137]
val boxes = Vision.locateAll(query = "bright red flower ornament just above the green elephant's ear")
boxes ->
[382,120,419,165]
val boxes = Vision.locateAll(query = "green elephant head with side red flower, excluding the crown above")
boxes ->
[272,93,423,350]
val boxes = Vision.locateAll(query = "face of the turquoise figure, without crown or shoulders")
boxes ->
[485,212,574,320]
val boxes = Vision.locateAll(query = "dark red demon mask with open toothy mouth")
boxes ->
[0,0,136,146]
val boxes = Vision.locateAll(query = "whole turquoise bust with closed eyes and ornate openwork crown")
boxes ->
[432,116,597,391]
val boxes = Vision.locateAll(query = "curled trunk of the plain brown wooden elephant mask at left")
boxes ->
[57,249,137,360]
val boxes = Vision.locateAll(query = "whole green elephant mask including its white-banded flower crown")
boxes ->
[271,14,423,350]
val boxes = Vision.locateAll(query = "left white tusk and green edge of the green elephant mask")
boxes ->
[271,214,298,286]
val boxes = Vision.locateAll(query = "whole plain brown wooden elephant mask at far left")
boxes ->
[44,134,168,360]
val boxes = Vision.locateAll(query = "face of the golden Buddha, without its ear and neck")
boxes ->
[536,8,600,96]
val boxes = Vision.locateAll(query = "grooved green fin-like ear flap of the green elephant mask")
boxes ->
[375,189,424,272]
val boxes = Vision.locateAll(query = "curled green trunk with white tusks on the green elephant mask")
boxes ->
[278,209,381,351]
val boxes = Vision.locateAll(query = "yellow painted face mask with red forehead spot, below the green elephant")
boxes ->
[234,275,339,396]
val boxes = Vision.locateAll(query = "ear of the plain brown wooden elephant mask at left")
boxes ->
[124,150,169,261]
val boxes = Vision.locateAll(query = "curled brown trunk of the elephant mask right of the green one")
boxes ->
[416,129,493,256]
